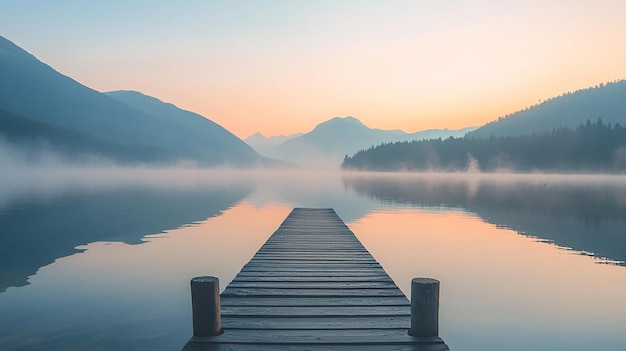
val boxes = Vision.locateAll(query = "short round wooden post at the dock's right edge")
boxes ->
[409,278,439,337]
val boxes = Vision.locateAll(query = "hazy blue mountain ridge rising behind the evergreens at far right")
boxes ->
[468,80,626,138]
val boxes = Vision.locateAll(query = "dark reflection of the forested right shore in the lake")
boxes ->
[344,175,626,262]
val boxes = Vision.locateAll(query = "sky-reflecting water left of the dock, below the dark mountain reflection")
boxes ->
[0,201,290,350]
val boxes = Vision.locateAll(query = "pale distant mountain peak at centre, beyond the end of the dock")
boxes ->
[258,117,472,168]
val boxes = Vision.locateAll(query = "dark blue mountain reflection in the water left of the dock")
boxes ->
[0,184,252,292]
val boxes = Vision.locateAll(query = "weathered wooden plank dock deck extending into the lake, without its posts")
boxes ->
[183,208,449,351]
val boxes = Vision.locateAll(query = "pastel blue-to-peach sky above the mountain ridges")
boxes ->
[0,0,626,138]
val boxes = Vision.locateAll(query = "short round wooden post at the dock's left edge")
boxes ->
[191,277,222,336]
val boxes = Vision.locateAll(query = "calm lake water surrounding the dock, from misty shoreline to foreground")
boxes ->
[0,169,626,351]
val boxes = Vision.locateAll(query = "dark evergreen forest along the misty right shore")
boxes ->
[341,119,626,173]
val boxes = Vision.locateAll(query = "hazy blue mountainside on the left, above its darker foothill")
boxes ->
[0,37,273,167]
